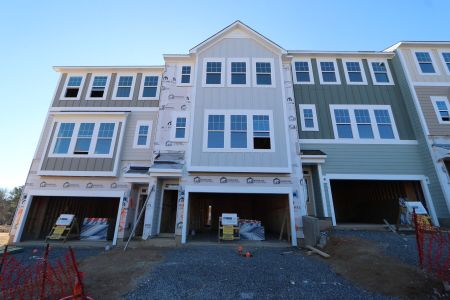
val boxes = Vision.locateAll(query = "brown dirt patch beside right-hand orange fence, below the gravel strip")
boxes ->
[324,236,444,299]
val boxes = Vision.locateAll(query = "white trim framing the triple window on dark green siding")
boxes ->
[330,104,400,142]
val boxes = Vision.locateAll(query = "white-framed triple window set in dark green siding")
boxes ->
[330,105,398,140]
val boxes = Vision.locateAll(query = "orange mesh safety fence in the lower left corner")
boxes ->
[0,244,90,300]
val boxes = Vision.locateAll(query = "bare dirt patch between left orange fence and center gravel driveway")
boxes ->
[80,247,169,300]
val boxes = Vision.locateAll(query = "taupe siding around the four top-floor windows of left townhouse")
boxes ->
[52,73,161,107]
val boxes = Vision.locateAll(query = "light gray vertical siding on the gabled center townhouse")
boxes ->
[191,38,289,168]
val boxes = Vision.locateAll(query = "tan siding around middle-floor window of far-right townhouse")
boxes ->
[415,86,450,136]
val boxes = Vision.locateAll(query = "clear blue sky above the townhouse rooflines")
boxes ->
[0,0,450,188]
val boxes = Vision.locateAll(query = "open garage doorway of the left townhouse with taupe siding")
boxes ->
[21,196,120,241]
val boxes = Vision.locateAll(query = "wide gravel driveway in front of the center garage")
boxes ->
[124,246,389,299]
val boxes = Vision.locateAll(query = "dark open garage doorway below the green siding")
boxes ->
[330,180,426,224]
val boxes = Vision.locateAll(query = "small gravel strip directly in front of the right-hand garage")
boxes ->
[331,230,419,267]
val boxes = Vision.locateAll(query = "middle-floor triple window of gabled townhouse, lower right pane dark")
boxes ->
[203,110,274,152]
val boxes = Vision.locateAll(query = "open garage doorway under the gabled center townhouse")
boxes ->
[187,193,290,242]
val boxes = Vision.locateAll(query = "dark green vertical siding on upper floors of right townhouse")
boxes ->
[294,59,415,140]
